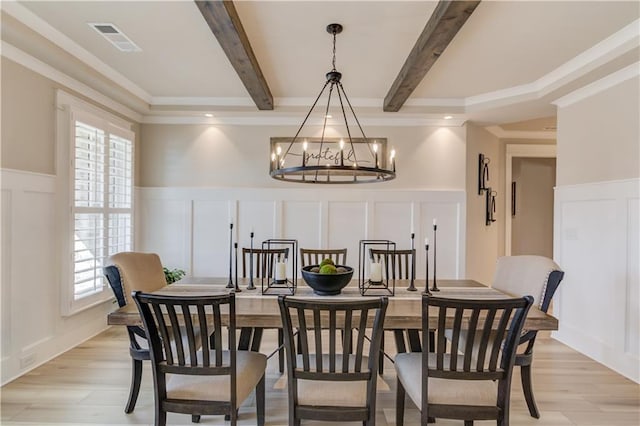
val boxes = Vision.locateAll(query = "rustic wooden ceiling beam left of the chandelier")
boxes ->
[196,0,273,110]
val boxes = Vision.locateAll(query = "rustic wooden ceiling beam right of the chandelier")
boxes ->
[382,0,480,112]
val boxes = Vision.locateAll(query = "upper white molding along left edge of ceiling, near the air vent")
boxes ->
[2,1,152,103]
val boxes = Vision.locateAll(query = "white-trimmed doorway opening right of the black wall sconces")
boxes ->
[505,144,556,259]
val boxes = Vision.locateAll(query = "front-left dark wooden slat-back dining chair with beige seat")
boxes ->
[133,291,267,426]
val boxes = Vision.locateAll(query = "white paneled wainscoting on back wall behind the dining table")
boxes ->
[136,187,465,279]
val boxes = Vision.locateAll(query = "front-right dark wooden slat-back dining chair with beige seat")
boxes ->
[395,295,533,426]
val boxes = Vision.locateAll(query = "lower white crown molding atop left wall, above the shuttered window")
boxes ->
[1,41,143,122]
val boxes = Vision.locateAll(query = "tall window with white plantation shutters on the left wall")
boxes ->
[58,91,134,314]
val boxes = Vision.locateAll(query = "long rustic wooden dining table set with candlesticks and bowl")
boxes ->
[107,277,558,352]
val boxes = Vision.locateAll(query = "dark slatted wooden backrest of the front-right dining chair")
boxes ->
[422,295,533,380]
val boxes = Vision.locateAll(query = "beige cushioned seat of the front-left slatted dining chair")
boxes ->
[167,351,267,406]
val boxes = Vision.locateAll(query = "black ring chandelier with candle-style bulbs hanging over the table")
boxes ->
[269,24,396,184]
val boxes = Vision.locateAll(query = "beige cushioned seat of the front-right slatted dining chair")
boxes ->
[395,352,498,407]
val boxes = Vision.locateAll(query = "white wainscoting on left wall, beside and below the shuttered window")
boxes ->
[0,169,114,384]
